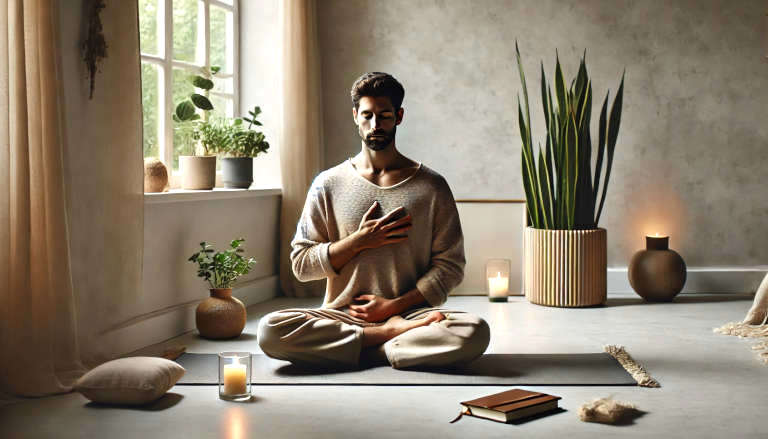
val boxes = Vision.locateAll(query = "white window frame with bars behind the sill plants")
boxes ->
[140,0,240,180]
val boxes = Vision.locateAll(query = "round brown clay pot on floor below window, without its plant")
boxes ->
[195,288,246,339]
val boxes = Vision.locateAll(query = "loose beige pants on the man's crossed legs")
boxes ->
[258,308,491,369]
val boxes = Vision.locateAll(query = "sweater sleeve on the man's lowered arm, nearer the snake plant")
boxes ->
[416,179,466,306]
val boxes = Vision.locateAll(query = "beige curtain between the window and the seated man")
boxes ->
[280,0,325,297]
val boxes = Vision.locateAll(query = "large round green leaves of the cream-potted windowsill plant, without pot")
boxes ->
[172,66,221,155]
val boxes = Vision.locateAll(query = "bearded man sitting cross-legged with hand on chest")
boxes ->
[258,72,490,368]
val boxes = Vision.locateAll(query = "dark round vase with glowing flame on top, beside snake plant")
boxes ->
[629,236,686,302]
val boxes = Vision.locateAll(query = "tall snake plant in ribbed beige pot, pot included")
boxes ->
[515,43,624,307]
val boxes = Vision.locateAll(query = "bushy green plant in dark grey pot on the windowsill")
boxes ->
[220,106,269,189]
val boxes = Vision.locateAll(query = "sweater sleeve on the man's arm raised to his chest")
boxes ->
[291,176,338,282]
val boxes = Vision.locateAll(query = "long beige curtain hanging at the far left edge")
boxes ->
[0,0,82,396]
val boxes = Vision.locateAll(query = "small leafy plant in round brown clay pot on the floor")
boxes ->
[188,238,256,339]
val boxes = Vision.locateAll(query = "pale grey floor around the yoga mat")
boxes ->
[0,295,768,439]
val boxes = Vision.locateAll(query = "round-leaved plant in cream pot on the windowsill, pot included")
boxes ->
[173,67,219,190]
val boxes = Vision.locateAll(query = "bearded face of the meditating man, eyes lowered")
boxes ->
[352,96,403,151]
